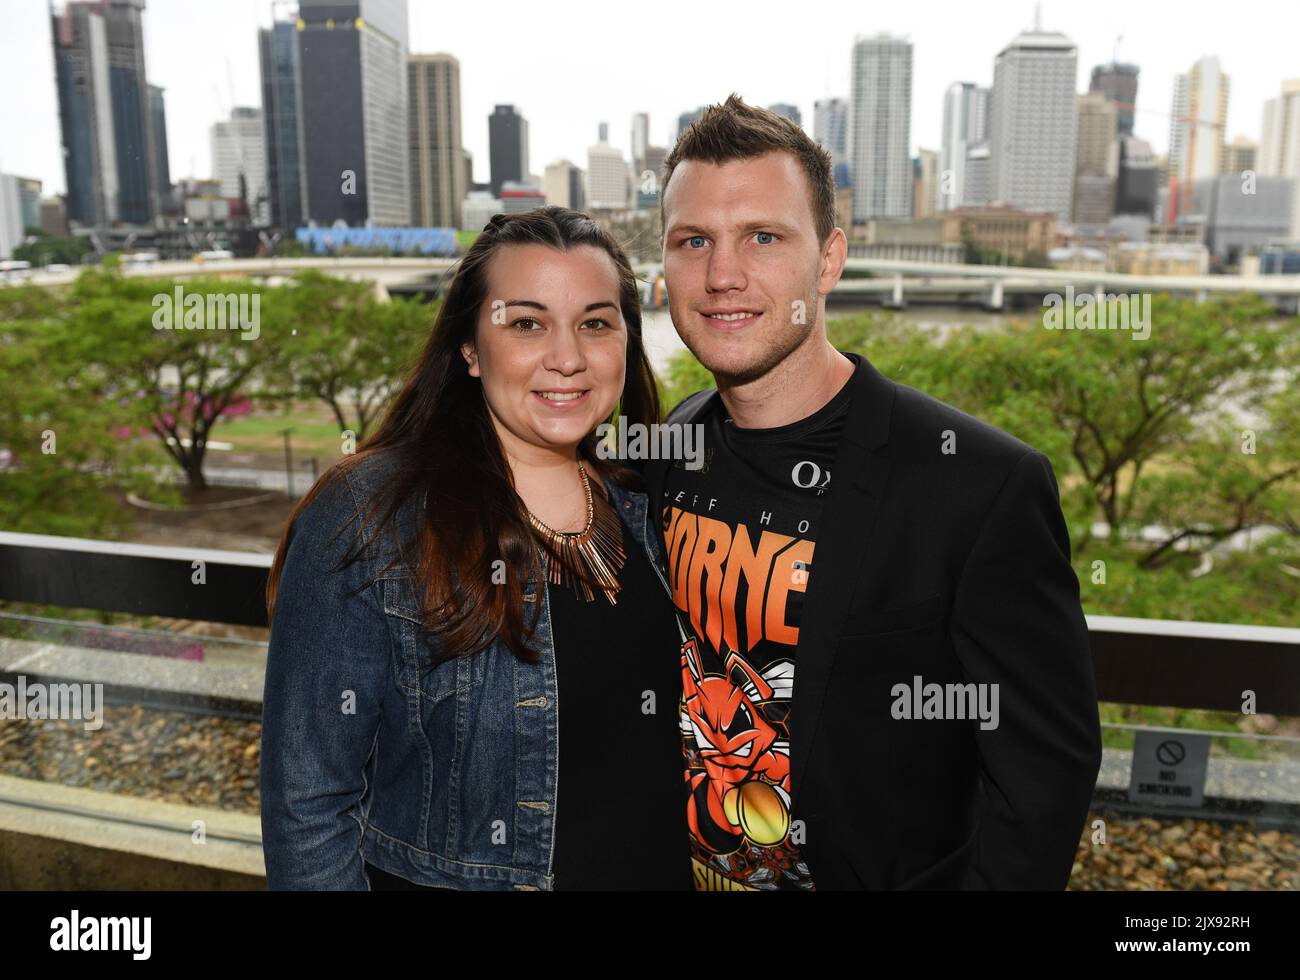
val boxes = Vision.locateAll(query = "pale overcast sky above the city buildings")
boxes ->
[0,0,1300,194]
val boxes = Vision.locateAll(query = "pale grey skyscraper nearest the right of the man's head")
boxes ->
[849,34,913,224]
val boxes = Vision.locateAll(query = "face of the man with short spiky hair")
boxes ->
[663,151,839,383]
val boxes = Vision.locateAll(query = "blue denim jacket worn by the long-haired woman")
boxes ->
[261,454,685,890]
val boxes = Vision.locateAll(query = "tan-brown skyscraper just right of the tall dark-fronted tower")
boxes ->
[410,55,469,227]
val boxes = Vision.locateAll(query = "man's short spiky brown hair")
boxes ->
[659,92,835,244]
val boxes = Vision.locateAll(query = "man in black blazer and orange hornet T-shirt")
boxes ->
[645,95,1101,889]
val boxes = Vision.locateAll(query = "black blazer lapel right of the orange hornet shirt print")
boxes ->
[790,356,894,808]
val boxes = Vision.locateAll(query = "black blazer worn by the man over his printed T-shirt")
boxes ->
[645,348,1101,890]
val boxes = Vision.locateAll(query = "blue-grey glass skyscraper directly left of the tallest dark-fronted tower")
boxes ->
[257,21,307,230]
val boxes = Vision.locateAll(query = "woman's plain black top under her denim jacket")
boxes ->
[365,521,693,892]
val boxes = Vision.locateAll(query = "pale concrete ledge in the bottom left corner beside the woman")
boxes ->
[0,776,267,890]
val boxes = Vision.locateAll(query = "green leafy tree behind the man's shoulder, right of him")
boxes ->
[832,289,1300,552]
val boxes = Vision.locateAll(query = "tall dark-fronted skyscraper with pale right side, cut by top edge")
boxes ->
[298,0,411,226]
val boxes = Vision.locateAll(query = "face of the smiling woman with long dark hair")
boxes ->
[462,244,628,456]
